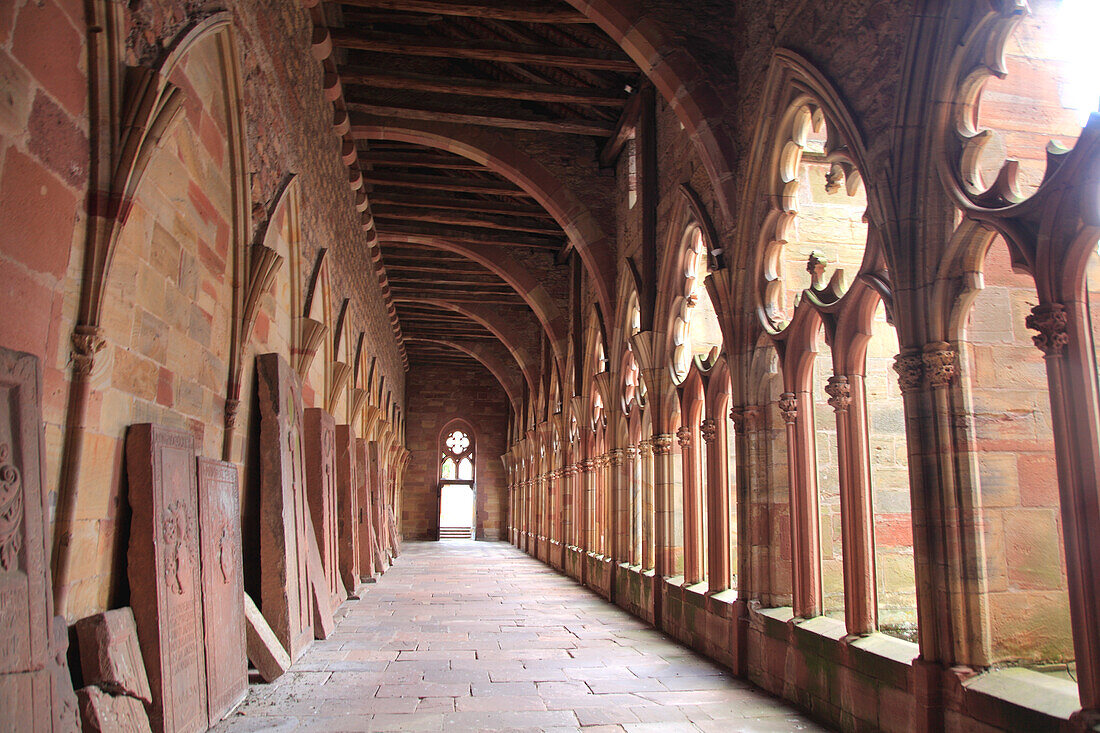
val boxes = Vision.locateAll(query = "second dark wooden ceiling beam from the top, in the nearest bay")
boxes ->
[332,29,638,74]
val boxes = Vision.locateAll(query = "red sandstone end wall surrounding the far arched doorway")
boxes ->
[400,365,509,539]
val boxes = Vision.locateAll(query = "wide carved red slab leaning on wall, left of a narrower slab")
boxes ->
[127,423,208,731]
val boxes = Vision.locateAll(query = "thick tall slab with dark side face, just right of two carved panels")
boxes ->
[256,353,314,660]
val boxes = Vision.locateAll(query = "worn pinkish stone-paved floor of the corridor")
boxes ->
[216,541,824,733]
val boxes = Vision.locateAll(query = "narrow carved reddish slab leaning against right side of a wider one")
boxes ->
[198,458,249,723]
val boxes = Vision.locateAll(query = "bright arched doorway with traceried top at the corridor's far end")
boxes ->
[439,423,476,539]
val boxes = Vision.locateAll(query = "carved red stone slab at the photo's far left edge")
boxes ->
[0,349,53,731]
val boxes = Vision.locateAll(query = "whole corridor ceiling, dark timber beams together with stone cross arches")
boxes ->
[323,0,640,401]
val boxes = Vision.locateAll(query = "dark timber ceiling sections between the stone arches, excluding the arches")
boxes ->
[323,0,640,394]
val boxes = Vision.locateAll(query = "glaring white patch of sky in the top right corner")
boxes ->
[1057,0,1100,124]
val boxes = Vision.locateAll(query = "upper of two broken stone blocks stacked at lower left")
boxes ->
[76,606,153,702]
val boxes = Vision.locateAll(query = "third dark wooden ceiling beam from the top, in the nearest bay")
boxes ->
[340,67,627,108]
